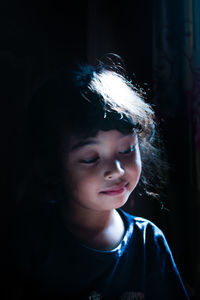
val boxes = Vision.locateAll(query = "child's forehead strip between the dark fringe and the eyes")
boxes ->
[68,130,136,152]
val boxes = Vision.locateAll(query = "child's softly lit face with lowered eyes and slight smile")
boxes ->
[64,130,141,211]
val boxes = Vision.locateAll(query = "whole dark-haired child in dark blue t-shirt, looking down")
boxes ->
[17,55,188,300]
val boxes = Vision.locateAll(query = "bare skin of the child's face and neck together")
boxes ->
[61,130,141,250]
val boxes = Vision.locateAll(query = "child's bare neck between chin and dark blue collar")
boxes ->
[61,205,125,250]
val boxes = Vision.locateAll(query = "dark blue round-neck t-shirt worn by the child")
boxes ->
[16,204,189,300]
